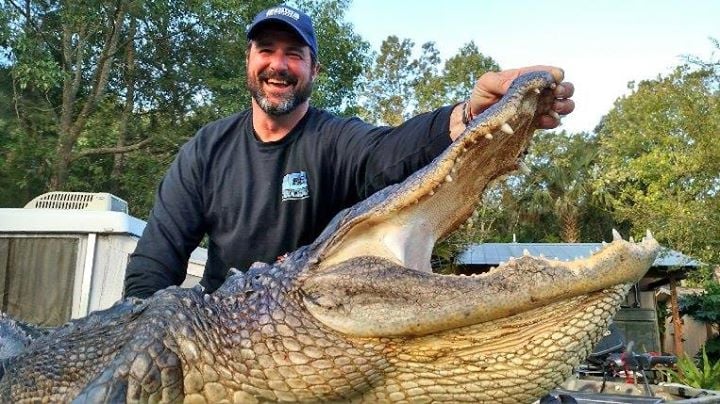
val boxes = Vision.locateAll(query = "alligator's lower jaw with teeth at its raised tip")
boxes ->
[303,232,659,337]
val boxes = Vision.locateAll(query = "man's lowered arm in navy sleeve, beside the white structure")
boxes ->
[123,141,205,298]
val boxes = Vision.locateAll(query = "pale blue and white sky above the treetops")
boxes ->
[346,0,720,132]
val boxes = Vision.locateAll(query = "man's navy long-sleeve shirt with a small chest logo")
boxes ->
[125,107,452,297]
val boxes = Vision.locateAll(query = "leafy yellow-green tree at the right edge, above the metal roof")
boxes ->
[595,66,720,263]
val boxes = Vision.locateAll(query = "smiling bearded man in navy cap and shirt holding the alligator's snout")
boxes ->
[125,6,574,297]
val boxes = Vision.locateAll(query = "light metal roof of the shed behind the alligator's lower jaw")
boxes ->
[457,243,700,268]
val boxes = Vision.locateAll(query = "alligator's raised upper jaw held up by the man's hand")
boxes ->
[315,72,555,272]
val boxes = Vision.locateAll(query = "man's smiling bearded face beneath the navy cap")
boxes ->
[247,25,317,116]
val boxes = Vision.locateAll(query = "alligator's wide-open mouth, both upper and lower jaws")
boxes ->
[302,72,657,337]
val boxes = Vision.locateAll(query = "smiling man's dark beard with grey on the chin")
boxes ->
[247,70,313,116]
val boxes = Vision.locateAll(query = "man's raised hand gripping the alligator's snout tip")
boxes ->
[470,66,575,129]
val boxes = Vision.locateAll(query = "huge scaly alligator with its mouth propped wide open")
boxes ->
[0,72,659,403]
